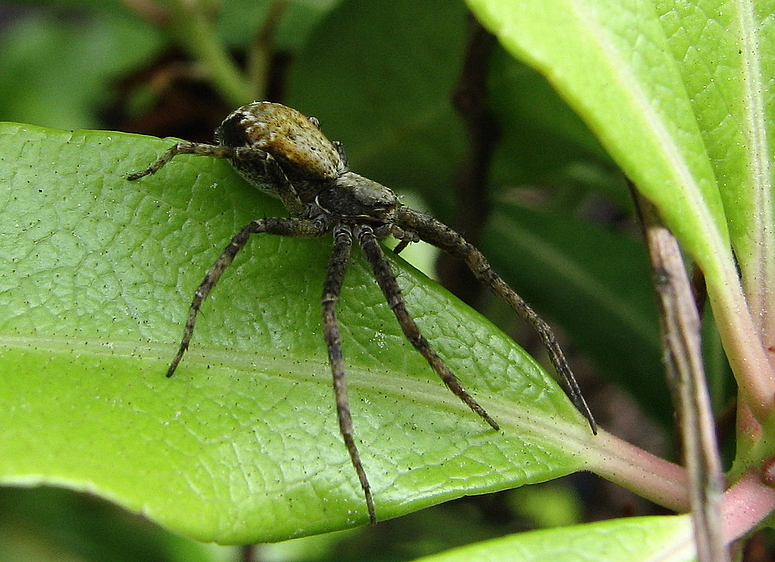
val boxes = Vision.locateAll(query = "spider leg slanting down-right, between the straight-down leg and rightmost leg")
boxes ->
[355,226,500,430]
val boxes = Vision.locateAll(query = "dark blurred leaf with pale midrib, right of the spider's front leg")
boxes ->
[482,203,673,420]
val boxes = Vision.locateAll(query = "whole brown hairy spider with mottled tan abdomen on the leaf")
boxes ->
[128,101,597,523]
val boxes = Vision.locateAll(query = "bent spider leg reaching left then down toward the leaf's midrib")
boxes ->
[167,214,328,377]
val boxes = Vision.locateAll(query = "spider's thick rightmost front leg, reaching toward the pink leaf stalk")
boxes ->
[396,207,597,434]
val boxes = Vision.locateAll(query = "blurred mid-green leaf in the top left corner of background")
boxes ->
[0,2,162,128]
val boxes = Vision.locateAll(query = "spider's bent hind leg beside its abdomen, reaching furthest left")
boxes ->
[127,141,305,216]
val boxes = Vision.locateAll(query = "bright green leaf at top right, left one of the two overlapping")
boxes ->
[470,0,729,270]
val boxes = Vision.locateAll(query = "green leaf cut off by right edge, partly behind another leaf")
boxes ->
[655,0,775,320]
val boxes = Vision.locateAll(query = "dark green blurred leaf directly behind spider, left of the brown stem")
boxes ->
[286,0,466,218]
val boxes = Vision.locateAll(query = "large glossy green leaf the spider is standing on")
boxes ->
[0,124,593,543]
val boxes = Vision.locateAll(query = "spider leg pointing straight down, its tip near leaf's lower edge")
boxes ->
[321,221,377,524]
